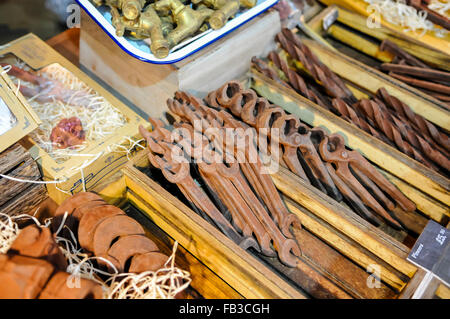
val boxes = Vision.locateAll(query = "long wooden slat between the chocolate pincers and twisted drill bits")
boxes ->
[252,70,450,209]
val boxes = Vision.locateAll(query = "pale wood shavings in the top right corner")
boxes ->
[364,0,447,37]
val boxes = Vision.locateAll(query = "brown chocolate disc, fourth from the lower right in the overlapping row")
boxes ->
[78,205,125,252]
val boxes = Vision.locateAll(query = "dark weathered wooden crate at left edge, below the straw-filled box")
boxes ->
[0,143,48,216]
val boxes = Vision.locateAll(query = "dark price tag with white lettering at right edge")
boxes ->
[407,220,450,285]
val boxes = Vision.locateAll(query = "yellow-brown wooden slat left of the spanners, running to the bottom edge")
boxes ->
[124,152,305,298]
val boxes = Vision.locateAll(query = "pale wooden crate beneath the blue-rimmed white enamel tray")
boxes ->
[80,11,280,117]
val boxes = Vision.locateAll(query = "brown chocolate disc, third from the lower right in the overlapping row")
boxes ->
[92,215,145,256]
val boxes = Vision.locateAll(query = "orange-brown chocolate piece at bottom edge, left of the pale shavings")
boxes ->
[39,272,103,299]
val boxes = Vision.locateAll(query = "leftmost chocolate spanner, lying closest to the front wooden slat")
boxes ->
[142,126,259,254]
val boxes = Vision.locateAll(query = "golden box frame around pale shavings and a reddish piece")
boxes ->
[0,33,148,204]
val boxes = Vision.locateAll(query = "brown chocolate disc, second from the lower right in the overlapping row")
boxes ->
[107,235,159,272]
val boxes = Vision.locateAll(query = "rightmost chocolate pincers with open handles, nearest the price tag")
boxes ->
[319,134,416,228]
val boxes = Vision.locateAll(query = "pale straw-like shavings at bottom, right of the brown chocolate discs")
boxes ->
[105,242,191,299]
